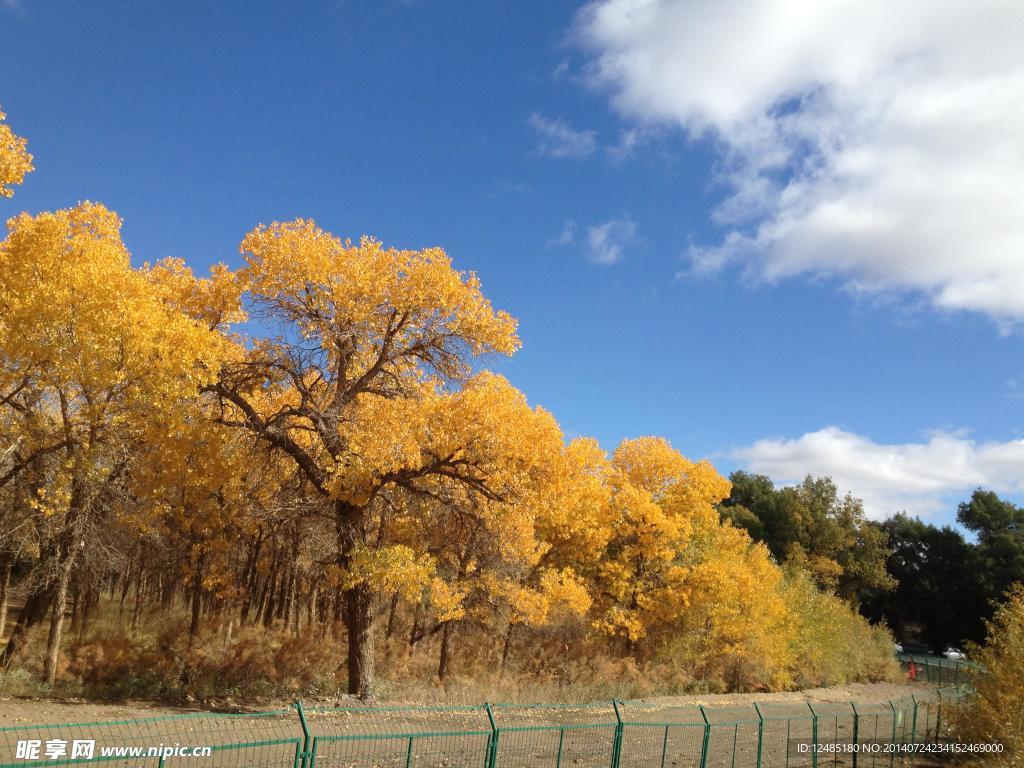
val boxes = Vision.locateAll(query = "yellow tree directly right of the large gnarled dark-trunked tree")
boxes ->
[378,380,591,679]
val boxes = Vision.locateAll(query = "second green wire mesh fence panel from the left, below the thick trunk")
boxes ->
[305,707,494,768]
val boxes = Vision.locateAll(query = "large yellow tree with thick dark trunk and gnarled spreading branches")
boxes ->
[207,219,519,696]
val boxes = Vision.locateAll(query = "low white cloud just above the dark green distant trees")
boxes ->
[732,427,1024,519]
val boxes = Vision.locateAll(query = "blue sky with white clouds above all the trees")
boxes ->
[6,0,1024,521]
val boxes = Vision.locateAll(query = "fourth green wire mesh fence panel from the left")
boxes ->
[618,701,706,768]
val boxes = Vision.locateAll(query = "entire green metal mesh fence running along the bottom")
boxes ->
[0,687,961,768]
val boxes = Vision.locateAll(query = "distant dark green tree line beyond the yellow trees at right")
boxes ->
[719,479,1024,651]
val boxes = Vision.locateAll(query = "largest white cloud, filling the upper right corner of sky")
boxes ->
[578,0,1024,323]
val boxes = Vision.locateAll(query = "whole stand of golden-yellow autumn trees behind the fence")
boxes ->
[0,102,901,697]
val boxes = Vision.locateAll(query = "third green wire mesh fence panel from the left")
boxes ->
[492,701,621,768]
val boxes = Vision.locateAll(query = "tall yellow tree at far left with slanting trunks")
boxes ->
[0,203,230,681]
